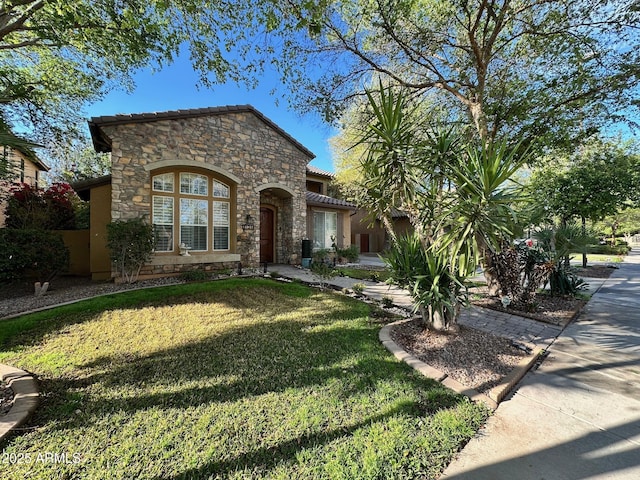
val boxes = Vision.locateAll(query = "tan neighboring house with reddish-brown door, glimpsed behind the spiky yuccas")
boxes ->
[351,208,413,253]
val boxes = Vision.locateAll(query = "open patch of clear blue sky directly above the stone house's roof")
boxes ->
[86,56,335,172]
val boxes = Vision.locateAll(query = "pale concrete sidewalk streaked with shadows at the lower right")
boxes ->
[442,251,640,480]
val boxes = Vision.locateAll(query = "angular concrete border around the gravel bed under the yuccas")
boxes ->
[378,319,542,410]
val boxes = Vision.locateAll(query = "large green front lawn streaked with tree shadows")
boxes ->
[0,279,487,479]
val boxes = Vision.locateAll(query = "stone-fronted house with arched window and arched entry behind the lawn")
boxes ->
[74,105,353,279]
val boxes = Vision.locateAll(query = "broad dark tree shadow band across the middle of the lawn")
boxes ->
[35,320,458,428]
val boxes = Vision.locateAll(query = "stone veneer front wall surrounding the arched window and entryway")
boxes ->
[95,107,313,275]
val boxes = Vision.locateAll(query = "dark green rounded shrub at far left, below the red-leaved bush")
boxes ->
[0,228,69,282]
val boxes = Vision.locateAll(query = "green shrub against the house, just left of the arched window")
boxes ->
[107,218,154,283]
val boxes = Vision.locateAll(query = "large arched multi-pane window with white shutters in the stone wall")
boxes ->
[151,172,231,252]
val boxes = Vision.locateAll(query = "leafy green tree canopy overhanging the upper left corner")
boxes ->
[0,0,282,143]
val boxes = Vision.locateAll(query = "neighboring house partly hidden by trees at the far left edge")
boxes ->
[0,145,49,227]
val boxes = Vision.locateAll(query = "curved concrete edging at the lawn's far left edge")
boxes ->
[0,364,40,440]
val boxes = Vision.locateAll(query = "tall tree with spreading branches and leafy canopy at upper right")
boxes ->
[262,0,640,150]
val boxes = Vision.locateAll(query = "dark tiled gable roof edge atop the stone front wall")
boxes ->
[88,105,315,159]
